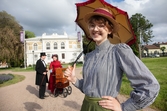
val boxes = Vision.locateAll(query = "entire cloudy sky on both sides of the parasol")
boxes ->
[0,0,167,44]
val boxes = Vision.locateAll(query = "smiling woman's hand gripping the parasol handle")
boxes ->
[64,64,77,84]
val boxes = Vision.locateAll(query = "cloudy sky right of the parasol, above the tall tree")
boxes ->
[110,0,167,43]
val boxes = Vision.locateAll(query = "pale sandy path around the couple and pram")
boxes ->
[0,68,156,111]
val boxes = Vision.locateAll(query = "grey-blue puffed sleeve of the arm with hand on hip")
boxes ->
[115,44,160,111]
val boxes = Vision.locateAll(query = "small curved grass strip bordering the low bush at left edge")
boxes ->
[0,74,25,87]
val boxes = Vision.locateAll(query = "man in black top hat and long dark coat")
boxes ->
[35,52,48,99]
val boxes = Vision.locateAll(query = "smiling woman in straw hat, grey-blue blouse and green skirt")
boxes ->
[64,8,160,111]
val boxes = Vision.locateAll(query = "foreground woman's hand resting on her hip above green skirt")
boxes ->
[99,96,122,111]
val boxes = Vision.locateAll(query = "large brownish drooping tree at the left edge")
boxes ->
[0,11,23,66]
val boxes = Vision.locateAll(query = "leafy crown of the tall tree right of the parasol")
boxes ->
[130,13,154,44]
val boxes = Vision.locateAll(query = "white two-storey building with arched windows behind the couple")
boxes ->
[25,33,83,66]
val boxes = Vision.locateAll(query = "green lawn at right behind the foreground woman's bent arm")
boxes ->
[120,57,167,111]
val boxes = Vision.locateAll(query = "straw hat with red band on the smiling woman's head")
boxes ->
[84,8,119,33]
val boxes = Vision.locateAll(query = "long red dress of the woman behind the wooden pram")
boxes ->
[48,60,62,93]
